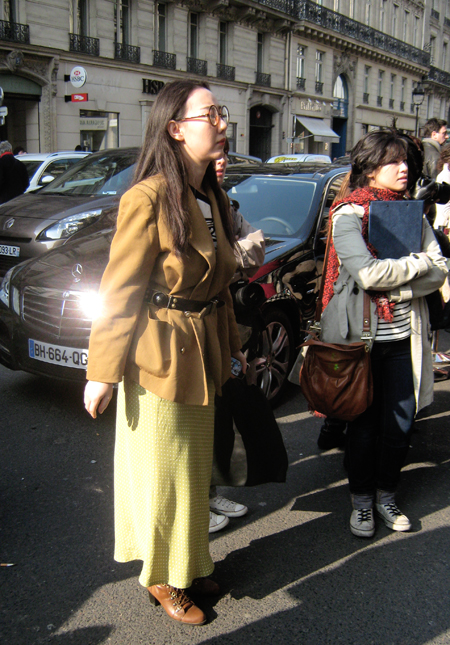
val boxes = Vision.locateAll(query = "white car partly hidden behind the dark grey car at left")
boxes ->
[16,150,90,193]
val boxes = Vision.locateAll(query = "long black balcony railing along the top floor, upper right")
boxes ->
[253,0,430,67]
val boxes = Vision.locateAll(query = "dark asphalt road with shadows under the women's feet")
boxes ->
[0,348,450,645]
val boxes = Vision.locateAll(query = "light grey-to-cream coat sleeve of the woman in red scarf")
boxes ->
[333,206,432,291]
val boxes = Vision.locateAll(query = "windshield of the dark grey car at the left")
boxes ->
[40,150,138,195]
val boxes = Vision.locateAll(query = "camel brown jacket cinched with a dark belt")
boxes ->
[87,175,241,405]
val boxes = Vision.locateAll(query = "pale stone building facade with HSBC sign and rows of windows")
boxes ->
[0,0,450,159]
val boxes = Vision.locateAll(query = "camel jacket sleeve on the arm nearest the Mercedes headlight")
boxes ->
[87,186,160,383]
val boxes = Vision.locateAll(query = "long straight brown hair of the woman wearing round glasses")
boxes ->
[133,79,234,255]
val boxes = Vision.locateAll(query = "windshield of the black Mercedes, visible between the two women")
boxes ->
[225,175,316,237]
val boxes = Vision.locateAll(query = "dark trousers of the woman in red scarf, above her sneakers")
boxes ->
[346,338,416,495]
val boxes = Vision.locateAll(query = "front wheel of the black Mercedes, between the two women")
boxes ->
[247,309,295,406]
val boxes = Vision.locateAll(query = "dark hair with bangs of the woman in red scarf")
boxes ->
[350,128,408,190]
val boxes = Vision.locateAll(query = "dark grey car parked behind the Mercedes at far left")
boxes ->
[0,148,139,276]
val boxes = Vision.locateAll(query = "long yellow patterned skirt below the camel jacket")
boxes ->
[114,378,214,589]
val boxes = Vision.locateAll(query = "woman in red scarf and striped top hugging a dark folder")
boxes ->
[321,130,447,537]
